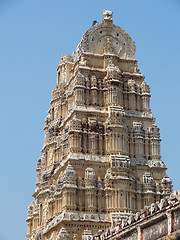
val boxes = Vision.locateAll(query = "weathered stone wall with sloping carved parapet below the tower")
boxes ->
[93,191,180,240]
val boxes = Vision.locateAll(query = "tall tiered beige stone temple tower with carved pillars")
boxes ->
[27,11,172,240]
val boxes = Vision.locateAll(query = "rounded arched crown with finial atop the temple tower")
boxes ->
[73,11,136,62]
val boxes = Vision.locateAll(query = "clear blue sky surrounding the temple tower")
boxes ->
[0,0,180,240]
